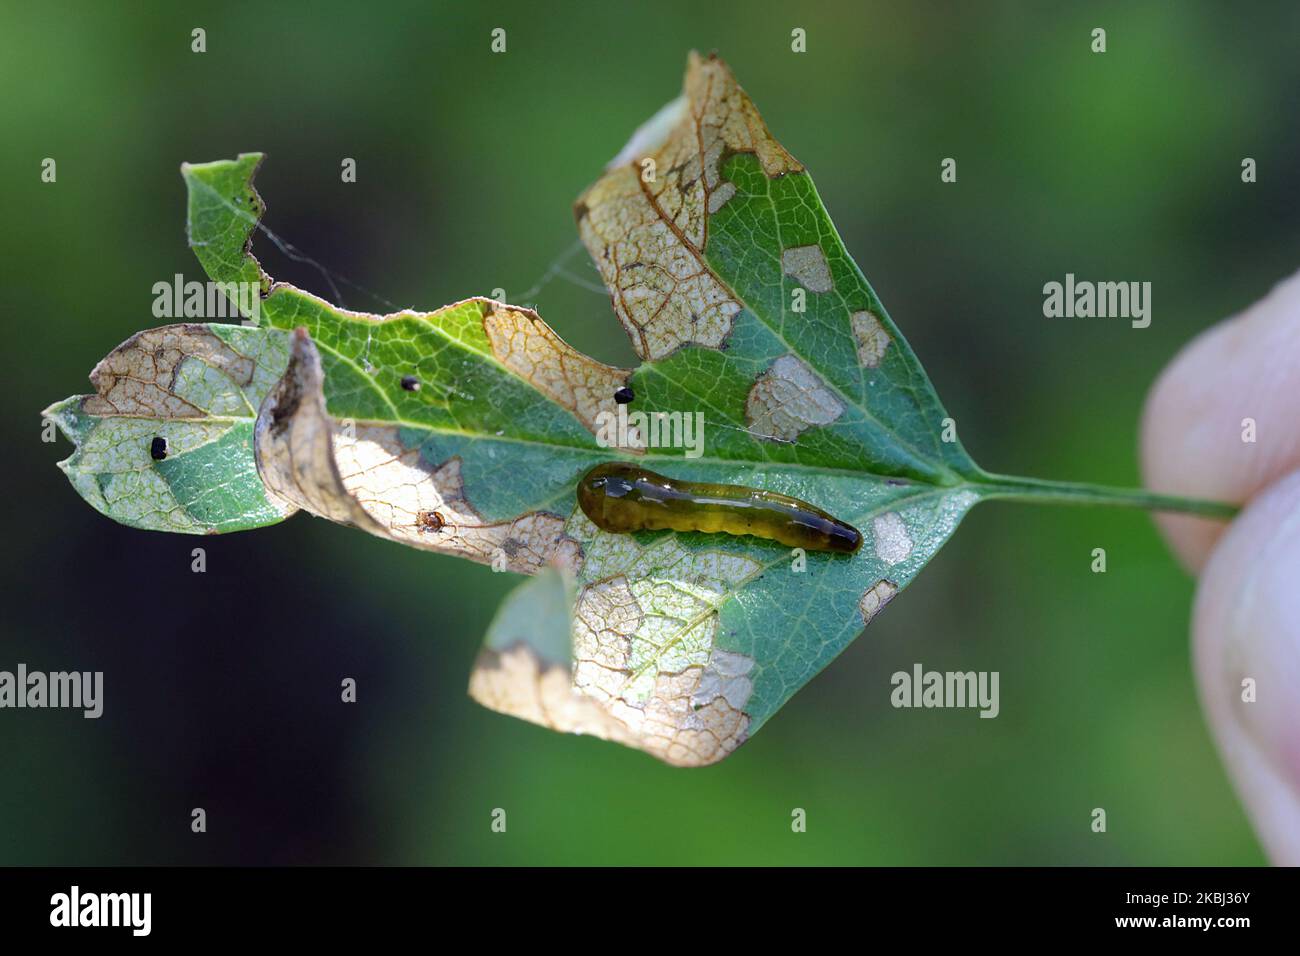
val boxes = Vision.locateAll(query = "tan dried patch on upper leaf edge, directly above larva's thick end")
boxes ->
[484,303,632,442]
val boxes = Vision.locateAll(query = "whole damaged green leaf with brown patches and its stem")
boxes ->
[47,55,1226,766]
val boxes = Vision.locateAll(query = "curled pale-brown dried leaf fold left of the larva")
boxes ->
[255,329,581,574]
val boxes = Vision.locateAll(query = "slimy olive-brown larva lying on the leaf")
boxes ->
[577,462,862,554]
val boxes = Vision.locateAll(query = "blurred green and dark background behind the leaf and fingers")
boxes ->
[0,0,1300,864]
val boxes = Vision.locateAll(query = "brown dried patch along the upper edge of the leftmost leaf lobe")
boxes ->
[82,324,256,419]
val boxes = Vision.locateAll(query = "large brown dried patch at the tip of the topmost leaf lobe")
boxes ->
[575,53,803,359]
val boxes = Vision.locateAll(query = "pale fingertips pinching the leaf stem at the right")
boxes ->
[1141,265,1300,866]
